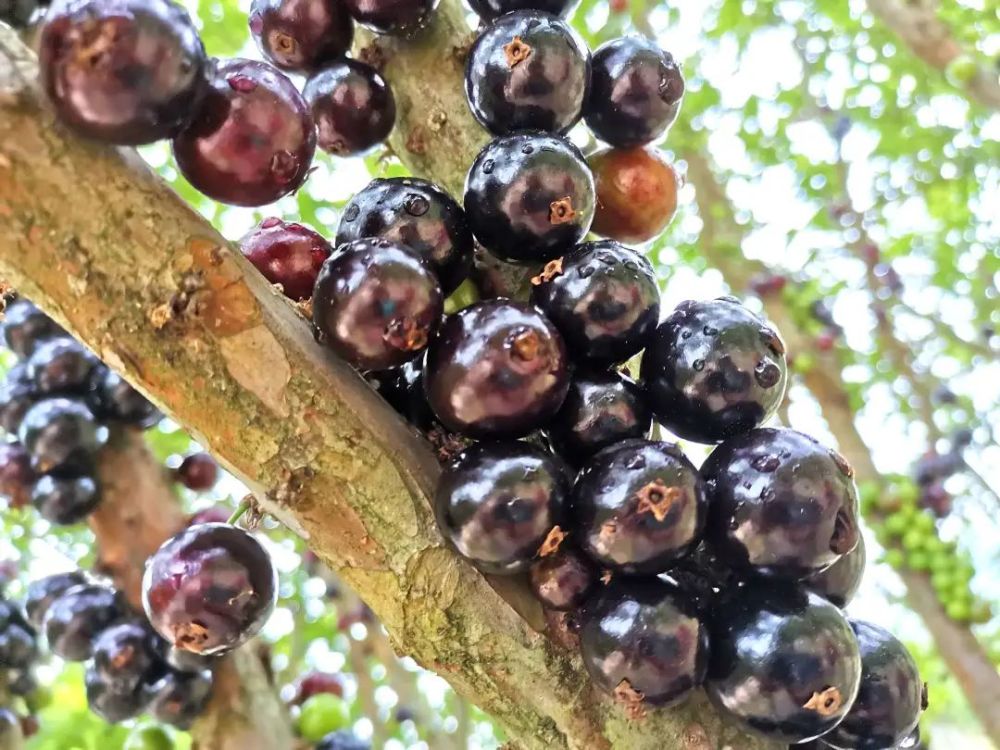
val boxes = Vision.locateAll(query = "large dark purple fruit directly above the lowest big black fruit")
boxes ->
[701,428,860,579]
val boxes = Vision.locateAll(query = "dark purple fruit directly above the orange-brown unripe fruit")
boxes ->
[585,36,684,148]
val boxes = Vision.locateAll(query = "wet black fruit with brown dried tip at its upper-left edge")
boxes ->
[531,240,660,365]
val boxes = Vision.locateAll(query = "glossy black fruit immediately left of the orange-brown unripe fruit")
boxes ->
[465,132,594,262]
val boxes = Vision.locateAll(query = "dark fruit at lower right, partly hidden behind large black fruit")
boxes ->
[823,620,927,750]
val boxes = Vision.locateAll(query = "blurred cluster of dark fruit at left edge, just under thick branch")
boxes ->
[0,299,160,524]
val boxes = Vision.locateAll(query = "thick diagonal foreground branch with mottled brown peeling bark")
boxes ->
[0,22,776,750]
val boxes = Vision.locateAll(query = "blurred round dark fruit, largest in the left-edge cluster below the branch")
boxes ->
[18,398,108,474]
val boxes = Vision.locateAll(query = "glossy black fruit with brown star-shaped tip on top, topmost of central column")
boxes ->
[465,10,590,135]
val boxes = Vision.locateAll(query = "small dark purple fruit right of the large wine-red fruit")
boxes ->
[302,59,396,156]
